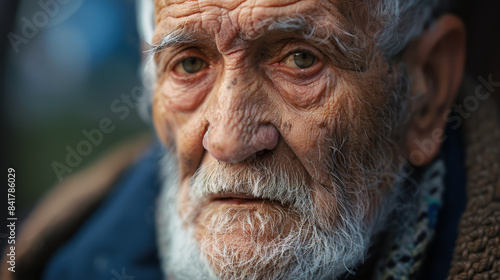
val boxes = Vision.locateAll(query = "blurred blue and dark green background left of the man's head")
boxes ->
[0,0,149,212]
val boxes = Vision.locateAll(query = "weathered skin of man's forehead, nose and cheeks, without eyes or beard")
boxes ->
[153,0,398,276]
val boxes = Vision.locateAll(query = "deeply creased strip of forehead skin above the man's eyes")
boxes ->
[155,0,342,42]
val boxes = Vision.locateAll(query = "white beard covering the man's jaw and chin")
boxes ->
[157,151,412,280]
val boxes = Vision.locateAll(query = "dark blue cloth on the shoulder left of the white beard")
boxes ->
[42,146,162,280]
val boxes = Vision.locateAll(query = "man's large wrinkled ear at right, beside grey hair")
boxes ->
[403,15,466,166]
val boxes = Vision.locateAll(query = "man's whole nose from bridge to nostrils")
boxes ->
[203,69,279,163]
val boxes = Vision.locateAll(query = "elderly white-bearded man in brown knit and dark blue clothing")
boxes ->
[3,0,500,279]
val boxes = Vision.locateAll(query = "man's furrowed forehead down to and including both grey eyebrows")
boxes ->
[150,0,370,71]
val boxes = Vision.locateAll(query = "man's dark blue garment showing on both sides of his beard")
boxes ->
[43,125,465,280]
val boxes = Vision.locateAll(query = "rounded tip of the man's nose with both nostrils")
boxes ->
[203,124,278,163]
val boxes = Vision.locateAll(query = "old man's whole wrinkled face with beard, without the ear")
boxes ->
[153,0,410,278]
